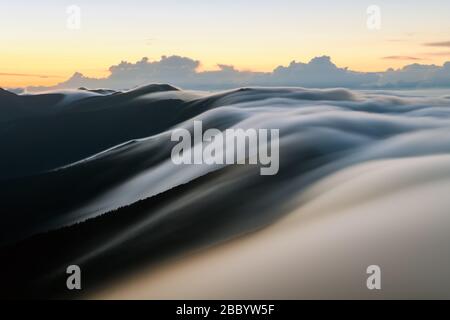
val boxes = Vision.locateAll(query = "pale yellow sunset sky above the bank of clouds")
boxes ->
[0,0,450,87]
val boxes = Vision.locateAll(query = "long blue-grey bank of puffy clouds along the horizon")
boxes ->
[28,55,450,91]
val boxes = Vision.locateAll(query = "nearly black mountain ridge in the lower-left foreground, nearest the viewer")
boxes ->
[0,169,285,298]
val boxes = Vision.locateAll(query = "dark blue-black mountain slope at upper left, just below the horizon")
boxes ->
[0,85,186,179]
